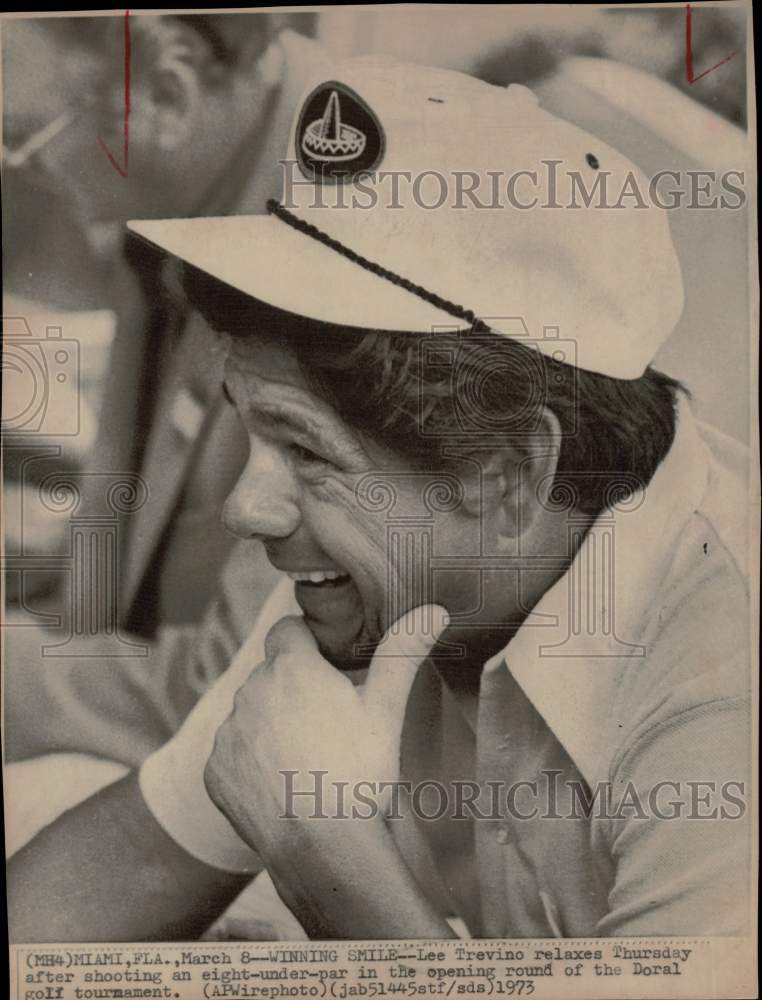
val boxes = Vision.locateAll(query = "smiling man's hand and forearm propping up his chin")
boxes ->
[205,607,450,937]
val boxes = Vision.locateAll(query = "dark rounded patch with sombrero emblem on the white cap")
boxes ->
[296,80,384,183]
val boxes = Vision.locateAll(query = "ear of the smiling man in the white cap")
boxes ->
[489,407,562,544]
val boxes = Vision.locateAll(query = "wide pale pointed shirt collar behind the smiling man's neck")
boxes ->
[485,400,709,783]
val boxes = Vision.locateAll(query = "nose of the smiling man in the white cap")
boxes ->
[222,445,301,540]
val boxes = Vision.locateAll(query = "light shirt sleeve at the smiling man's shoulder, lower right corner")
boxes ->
[594,697,753,936]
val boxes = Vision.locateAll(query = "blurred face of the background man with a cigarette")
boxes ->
[3,19,202,225]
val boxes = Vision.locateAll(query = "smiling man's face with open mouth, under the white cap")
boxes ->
[225,338,490,669]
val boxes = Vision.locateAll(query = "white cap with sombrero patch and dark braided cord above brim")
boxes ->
[129,57,683,379]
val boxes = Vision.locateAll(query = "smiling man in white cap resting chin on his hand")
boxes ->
[5,60,749,940]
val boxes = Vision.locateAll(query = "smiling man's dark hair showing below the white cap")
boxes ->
[183,267,684,514]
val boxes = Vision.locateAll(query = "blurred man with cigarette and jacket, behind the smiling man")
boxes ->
[3,14,326,936]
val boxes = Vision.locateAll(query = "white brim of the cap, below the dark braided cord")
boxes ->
[127,215,458,333]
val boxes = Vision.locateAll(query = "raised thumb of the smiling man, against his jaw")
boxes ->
[361,604,450,739]
